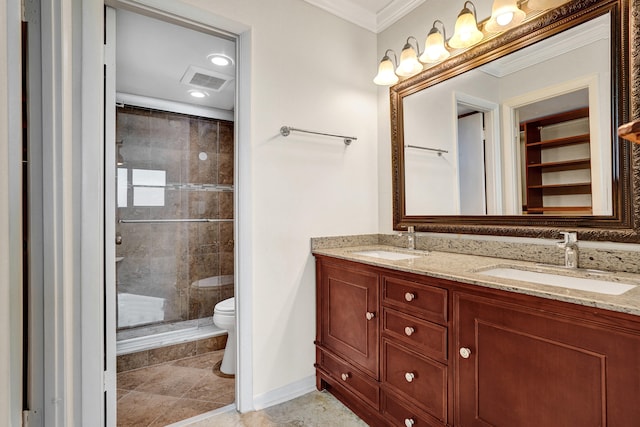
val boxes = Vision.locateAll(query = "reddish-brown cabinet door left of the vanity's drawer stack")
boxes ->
[319,265,379,379]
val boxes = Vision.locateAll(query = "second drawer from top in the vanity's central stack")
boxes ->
[382,308,447,360]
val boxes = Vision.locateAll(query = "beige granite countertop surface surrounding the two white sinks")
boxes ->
[313,245,640,316]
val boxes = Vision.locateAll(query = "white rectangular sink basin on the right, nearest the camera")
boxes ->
[478,267,636,295]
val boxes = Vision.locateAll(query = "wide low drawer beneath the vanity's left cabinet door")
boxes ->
[319,351,380,410]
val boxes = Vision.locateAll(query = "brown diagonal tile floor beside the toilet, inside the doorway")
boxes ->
[116,350,235,427]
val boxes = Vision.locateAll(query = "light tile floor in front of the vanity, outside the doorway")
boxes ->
[188,391,367,427]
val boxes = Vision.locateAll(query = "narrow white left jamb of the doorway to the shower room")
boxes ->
[104,7,116,426]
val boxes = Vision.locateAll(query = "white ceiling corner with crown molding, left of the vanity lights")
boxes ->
[304,0,425,33]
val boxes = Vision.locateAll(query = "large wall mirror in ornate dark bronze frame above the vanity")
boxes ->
[391,0,638,241]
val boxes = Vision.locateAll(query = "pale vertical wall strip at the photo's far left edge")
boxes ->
[0,0,22,427]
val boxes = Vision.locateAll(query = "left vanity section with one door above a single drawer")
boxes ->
[315,258,385,425]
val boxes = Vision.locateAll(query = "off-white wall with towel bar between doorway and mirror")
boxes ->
[180,0,378,396]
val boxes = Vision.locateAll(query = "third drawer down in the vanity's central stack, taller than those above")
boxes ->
[382,338,447,422]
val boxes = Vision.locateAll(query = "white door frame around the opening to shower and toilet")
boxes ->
[104,0,254,422]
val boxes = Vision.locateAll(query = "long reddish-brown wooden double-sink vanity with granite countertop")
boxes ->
[314,247,640,427]
